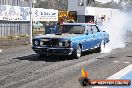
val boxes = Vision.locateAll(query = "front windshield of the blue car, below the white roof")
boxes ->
[58,25,85,34]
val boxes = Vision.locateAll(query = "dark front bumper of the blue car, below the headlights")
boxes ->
[32,46,73,55]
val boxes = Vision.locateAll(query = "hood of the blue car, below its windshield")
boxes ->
[35,34,82,39]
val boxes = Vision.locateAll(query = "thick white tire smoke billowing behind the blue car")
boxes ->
[102,11,132,53]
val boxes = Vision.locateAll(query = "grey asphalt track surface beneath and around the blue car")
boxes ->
[0,33,132,88]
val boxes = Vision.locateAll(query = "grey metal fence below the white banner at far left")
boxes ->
[0,21,30,37]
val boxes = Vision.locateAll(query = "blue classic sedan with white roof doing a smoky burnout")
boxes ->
[32,23,109,58]
